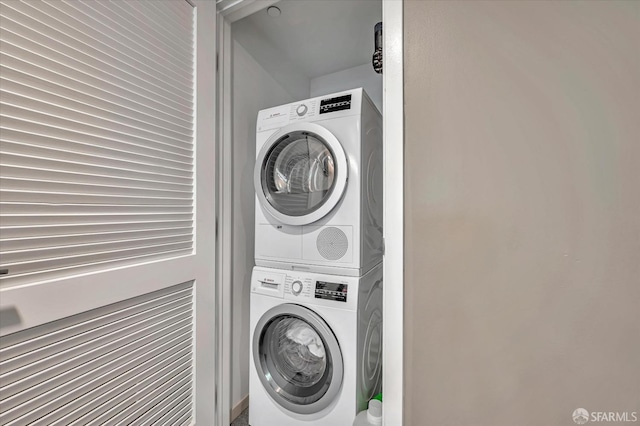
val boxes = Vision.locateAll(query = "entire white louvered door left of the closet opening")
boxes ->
[0,0,215,425]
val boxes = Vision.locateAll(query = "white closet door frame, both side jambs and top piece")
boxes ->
[215,0,404,426]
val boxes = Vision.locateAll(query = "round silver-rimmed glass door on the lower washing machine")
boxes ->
[253,304,343,414]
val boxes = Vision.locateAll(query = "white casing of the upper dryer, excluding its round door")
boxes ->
[255,89,383,276]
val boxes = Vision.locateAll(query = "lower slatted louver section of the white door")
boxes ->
[0,282,194,426]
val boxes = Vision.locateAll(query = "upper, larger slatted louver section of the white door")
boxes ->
[0,0,195,287]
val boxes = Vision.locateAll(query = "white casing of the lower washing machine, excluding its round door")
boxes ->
[249,264,382,426]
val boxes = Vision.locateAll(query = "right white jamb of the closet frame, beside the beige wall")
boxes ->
[382,0,404,426]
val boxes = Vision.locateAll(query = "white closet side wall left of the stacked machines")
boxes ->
[231,41,298,408]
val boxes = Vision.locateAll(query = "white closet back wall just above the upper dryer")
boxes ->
[310,63,382,112]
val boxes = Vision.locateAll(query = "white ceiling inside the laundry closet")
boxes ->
[234,0,382,78]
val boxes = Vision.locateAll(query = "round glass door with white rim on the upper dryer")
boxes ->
[254,123,348,225]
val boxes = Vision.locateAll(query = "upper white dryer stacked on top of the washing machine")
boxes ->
[254,89,383,276]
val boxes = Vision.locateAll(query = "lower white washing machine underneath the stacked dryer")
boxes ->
[249,264,382,426]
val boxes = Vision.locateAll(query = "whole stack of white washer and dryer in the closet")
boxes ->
[249,89,383,426]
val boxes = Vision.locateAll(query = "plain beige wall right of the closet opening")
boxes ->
[404,0,640,426]
